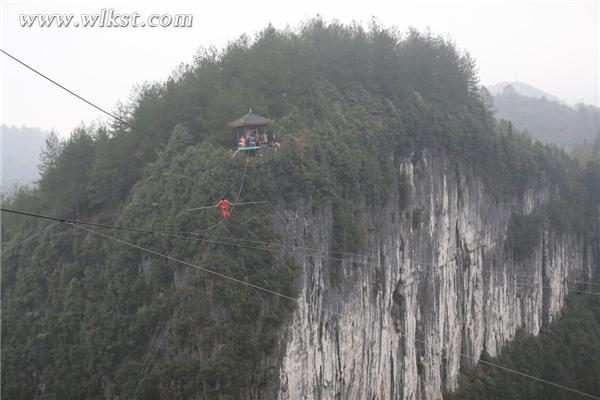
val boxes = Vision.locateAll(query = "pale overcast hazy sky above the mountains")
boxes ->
[0,0,600,136]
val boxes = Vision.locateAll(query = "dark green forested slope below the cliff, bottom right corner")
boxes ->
[449,295,600,400]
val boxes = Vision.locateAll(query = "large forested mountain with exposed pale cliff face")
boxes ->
[1,19,600,399]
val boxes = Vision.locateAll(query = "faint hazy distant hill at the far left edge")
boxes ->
[0,125,47,193]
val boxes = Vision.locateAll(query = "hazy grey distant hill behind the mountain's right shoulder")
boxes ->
[490,84,600,149]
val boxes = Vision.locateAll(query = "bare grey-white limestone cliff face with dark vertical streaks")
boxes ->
[270,153,599,400]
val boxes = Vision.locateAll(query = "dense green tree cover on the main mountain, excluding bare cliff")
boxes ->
[2,19,600,399]
